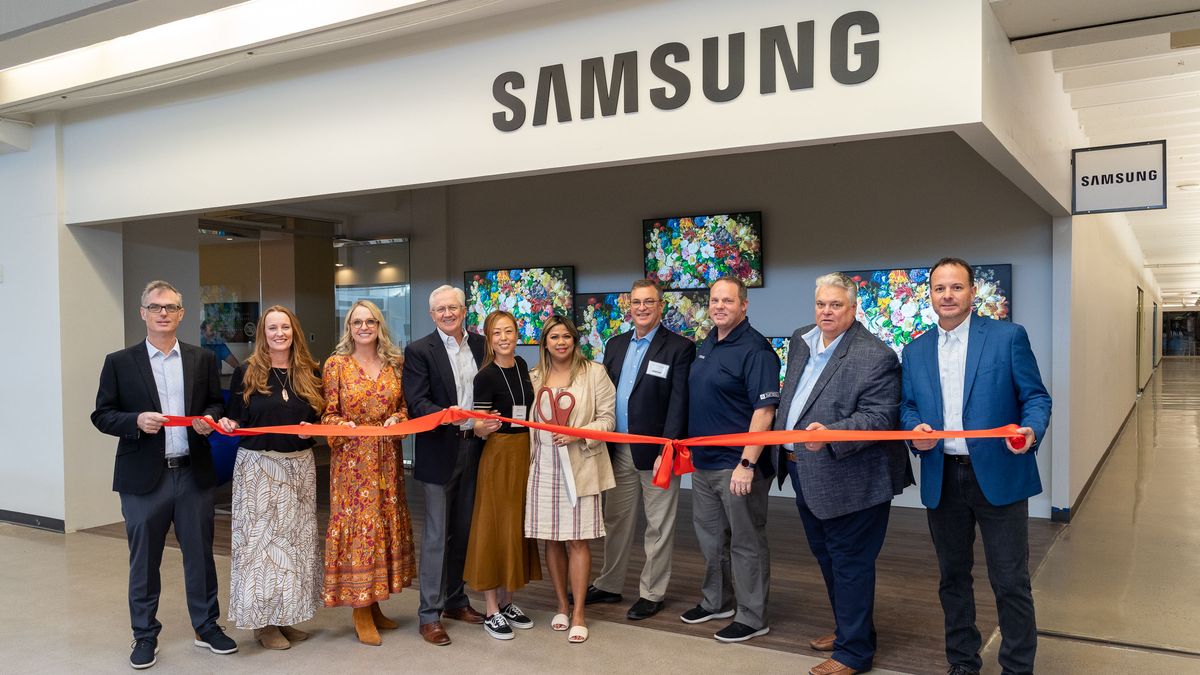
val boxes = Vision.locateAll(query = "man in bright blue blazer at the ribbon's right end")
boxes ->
[900,258,1050,675]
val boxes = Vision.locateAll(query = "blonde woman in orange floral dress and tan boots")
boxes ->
[322,300,416,645]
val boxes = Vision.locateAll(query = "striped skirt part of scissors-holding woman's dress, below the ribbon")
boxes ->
[524,431,605,542]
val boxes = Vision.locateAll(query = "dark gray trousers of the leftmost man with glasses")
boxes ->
[120,467,221,639]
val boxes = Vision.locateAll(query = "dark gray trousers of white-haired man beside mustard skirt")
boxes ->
[416,438,479,626]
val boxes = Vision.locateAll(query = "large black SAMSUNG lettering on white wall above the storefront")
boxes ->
[492,11,880,131]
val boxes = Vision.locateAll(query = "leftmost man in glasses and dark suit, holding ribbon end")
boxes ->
[91,281,238,669]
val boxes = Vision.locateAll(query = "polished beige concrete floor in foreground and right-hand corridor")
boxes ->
[7,359,1200,674]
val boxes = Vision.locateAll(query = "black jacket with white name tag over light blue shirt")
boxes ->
[604,324,696,471]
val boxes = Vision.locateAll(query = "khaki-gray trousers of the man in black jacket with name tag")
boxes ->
[594,443,679,602]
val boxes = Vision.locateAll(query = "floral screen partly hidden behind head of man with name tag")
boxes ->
[575,291,713,362]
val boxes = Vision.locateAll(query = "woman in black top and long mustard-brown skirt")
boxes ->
[462,311,541,640]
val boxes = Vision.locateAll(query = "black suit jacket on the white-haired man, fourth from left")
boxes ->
[401,330,484,485]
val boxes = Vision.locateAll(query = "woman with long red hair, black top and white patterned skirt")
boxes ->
[213,305,325,650]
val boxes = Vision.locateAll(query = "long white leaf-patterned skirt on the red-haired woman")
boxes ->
[229,448,320,629]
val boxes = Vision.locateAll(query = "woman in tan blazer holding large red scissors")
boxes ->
[524,316,617,644]
